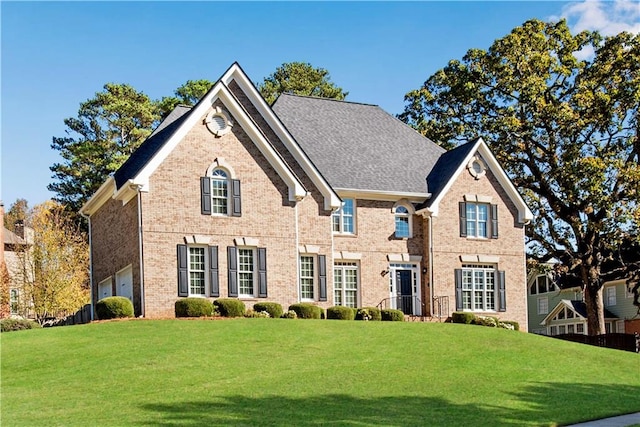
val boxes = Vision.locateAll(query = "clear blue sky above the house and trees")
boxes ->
[0,0,640,209]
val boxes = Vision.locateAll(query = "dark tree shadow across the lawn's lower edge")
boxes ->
[139,383,640,427]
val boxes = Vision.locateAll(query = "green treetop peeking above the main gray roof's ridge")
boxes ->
[258,62,349,105]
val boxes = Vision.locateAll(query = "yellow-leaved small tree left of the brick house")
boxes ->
[14,201,89,324]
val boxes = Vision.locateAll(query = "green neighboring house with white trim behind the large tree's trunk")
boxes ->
[528,274,640,335]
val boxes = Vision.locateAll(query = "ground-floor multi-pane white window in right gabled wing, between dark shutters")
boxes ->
[462,264,497,311]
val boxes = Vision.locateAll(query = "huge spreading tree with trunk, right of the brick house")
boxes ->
[400,20,640,334]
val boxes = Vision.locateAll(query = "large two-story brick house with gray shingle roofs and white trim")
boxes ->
[82,64,532,330]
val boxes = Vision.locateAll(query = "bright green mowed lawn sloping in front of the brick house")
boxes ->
[1,319,640,426]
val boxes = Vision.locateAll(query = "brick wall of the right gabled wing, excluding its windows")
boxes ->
[433,160,527,331]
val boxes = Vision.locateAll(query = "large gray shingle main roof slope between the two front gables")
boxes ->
[272,94,445,194]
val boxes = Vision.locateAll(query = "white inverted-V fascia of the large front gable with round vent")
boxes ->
[132,82,307,201]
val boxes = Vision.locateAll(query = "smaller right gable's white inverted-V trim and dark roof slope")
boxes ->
[418,138,533,224]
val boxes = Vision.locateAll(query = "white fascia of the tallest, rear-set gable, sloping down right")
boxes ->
[220,63,342,210]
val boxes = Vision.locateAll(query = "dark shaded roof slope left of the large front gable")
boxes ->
[113,105,191,188]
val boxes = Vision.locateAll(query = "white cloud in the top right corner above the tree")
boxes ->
[560,0,640,36]
